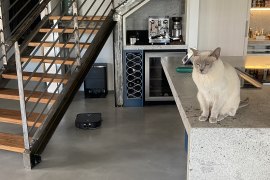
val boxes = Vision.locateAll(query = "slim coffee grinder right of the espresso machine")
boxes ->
[171,17,183,42]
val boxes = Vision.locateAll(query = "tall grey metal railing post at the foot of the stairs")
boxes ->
[14,41,31,169]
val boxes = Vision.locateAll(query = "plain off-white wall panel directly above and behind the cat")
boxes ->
[198,0,249,56]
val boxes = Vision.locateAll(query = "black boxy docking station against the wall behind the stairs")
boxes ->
[84,63,108,98]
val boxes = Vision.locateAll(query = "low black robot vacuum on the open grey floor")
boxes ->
[75,113,102,130]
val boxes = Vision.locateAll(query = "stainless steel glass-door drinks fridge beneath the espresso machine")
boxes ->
[144,50,186,102]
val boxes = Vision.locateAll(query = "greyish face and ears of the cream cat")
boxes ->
[191,48,220,74]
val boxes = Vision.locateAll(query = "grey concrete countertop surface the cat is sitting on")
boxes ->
[162,57,270,134]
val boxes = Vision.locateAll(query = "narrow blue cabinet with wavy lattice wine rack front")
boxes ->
[123,50,144,107]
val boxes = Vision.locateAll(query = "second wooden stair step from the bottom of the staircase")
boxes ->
[0,109,46,127]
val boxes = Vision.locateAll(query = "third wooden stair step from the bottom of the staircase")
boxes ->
[0,88,57,104]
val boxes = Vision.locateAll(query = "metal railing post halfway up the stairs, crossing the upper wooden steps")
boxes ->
[72,0,81,66]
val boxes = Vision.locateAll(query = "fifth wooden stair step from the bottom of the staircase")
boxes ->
[21,56,76,65]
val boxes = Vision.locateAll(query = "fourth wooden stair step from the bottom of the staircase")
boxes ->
[2,72,68,84]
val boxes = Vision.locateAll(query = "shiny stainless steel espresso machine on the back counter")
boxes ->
[148,16,170,44]
